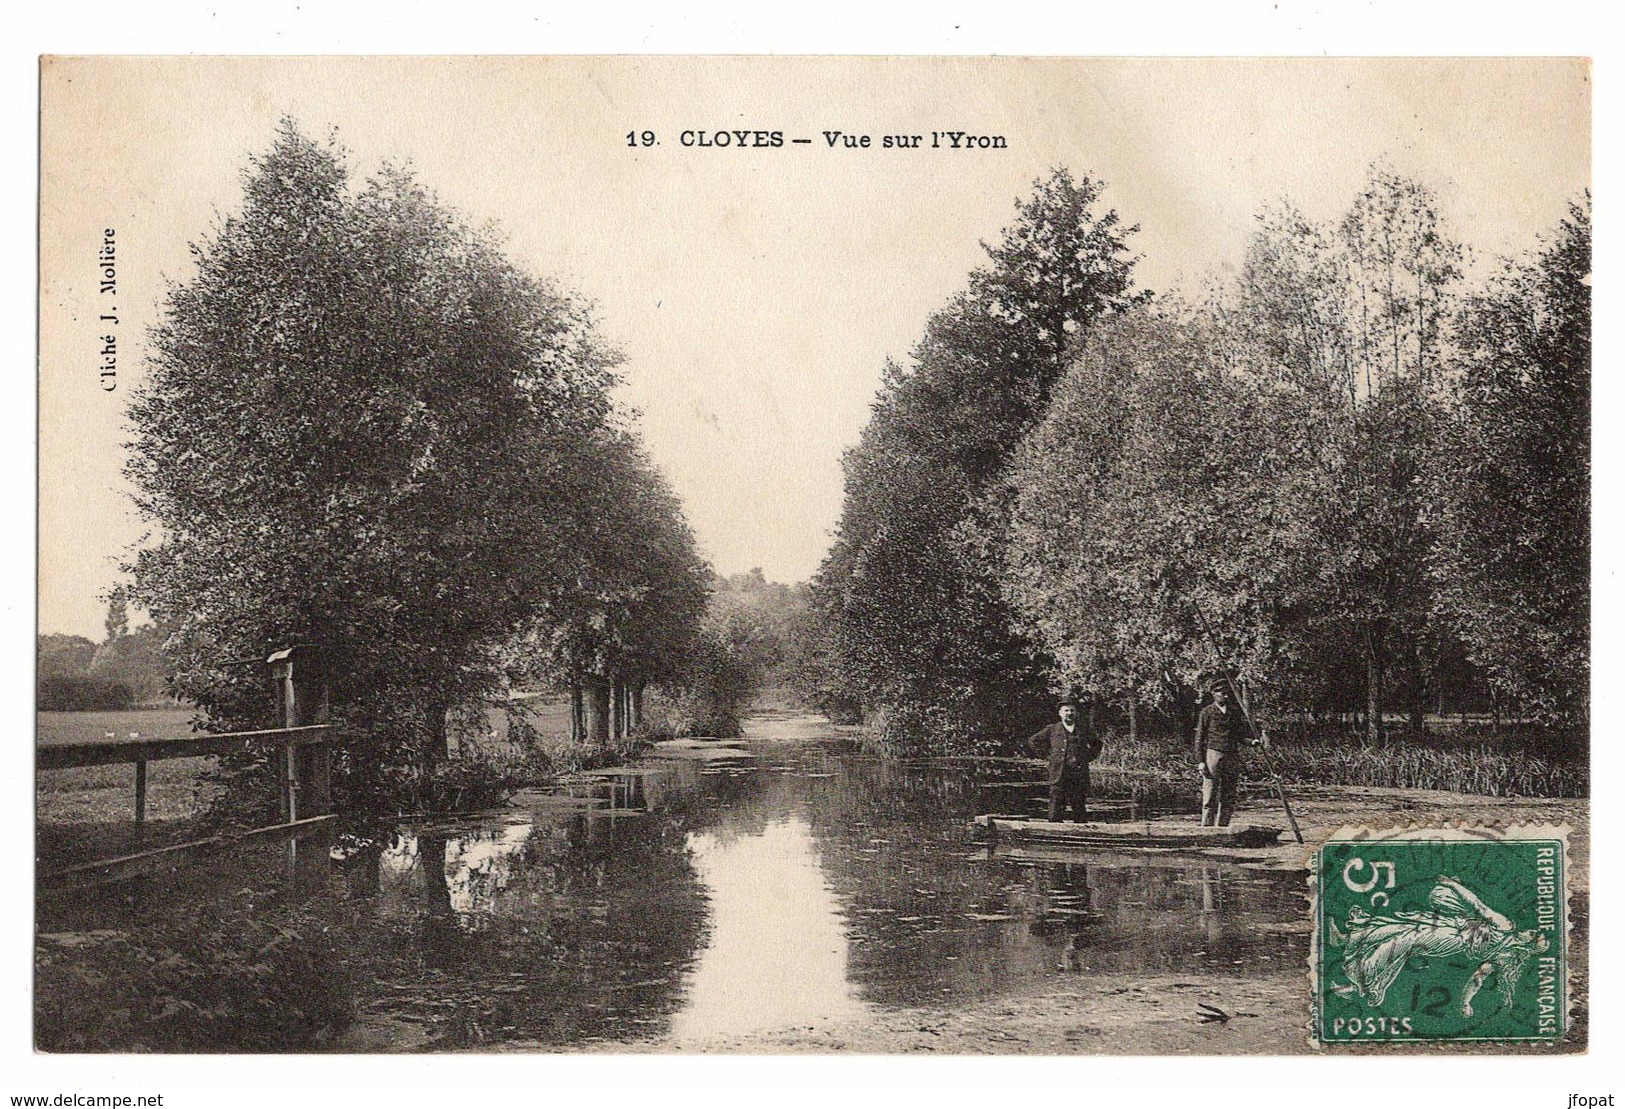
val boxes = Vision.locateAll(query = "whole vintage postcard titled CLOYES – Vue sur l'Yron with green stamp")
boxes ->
[31,57,1591,1073]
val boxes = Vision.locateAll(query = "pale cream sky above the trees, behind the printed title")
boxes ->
[39,57,1591,639]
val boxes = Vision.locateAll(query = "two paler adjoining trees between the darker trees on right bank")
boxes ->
[993,169,1488,740]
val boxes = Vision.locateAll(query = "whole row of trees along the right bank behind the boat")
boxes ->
[814,171,1589,748]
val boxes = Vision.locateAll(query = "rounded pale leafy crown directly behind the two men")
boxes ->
[1003,301,1285,707]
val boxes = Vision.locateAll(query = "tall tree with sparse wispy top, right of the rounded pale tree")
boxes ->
[1235,169,1463,740]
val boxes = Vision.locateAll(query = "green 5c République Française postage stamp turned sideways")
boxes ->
[1310,828,1568,1044]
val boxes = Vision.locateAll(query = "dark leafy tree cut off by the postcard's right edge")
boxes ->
[1428,197,1591,725]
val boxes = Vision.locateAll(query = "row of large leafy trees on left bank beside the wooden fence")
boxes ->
[127,122,709,800]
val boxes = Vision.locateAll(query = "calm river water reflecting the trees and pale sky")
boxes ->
[41,717,1305,1049]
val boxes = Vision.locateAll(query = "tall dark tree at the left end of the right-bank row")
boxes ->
[814,169,1134,751]
